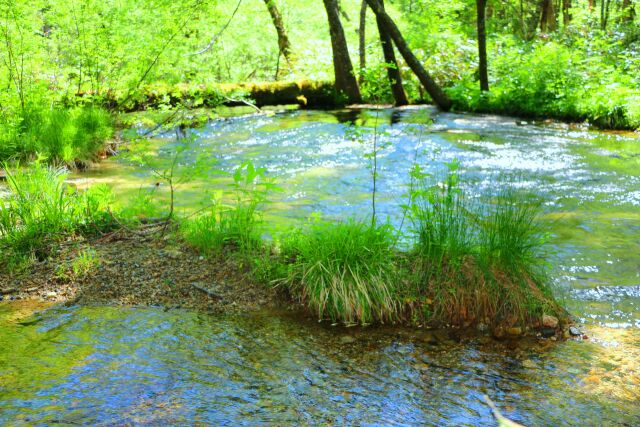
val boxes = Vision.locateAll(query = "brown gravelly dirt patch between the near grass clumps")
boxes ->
[0,232,277,312]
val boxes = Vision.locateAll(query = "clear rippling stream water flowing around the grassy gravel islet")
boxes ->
[0,109,640,426]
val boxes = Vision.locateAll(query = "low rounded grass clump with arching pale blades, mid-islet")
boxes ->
[282,220,399,324]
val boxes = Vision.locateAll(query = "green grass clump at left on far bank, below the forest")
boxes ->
[0,106,114,167]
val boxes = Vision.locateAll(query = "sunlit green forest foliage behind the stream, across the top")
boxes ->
[0,0,640,166]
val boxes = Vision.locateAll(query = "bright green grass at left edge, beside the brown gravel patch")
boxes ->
[0,162,114,268]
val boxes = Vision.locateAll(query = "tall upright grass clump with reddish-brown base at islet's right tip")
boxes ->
[406,164,562,327]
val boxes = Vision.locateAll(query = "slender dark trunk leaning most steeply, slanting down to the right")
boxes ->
[367,0,451,111]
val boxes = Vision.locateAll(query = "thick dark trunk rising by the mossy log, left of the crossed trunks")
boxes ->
[323,0,362,103]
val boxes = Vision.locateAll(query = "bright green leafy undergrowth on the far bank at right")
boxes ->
[447,41,640,129]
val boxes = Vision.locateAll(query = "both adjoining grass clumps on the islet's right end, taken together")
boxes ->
[275,163,566,330]
